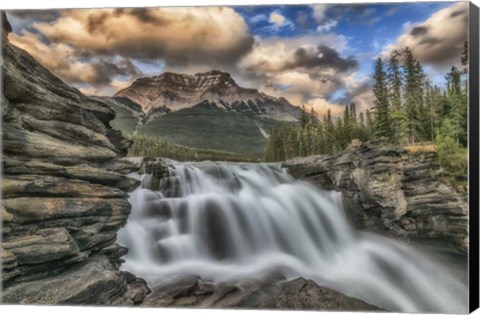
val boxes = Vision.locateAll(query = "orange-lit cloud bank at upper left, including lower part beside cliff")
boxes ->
[9,7,254,95]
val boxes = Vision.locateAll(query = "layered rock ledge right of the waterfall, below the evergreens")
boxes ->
[284,141,468,253]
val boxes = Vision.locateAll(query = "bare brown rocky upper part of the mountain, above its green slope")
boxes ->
[114,70,301,121]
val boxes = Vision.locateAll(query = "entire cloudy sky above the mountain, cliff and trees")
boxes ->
[3,2,468,115]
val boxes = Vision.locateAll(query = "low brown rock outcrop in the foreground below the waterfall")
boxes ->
[142,274,381,312]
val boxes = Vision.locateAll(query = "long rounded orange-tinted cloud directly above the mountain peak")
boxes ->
[23,7,253,64]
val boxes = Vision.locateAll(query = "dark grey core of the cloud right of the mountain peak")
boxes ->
[287,45,358,72]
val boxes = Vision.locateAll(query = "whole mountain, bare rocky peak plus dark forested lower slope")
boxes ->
[103,70,301,158]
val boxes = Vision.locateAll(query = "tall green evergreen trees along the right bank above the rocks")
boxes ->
[266,42,468,175]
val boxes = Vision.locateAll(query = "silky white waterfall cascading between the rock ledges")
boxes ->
[119,161,468,313]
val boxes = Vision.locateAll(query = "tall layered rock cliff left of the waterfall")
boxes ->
[1,15,148,305]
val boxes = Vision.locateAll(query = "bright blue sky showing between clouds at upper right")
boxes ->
[235,2,452,79]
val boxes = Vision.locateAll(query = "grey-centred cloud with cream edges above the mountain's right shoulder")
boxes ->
[237,33,358,110]
